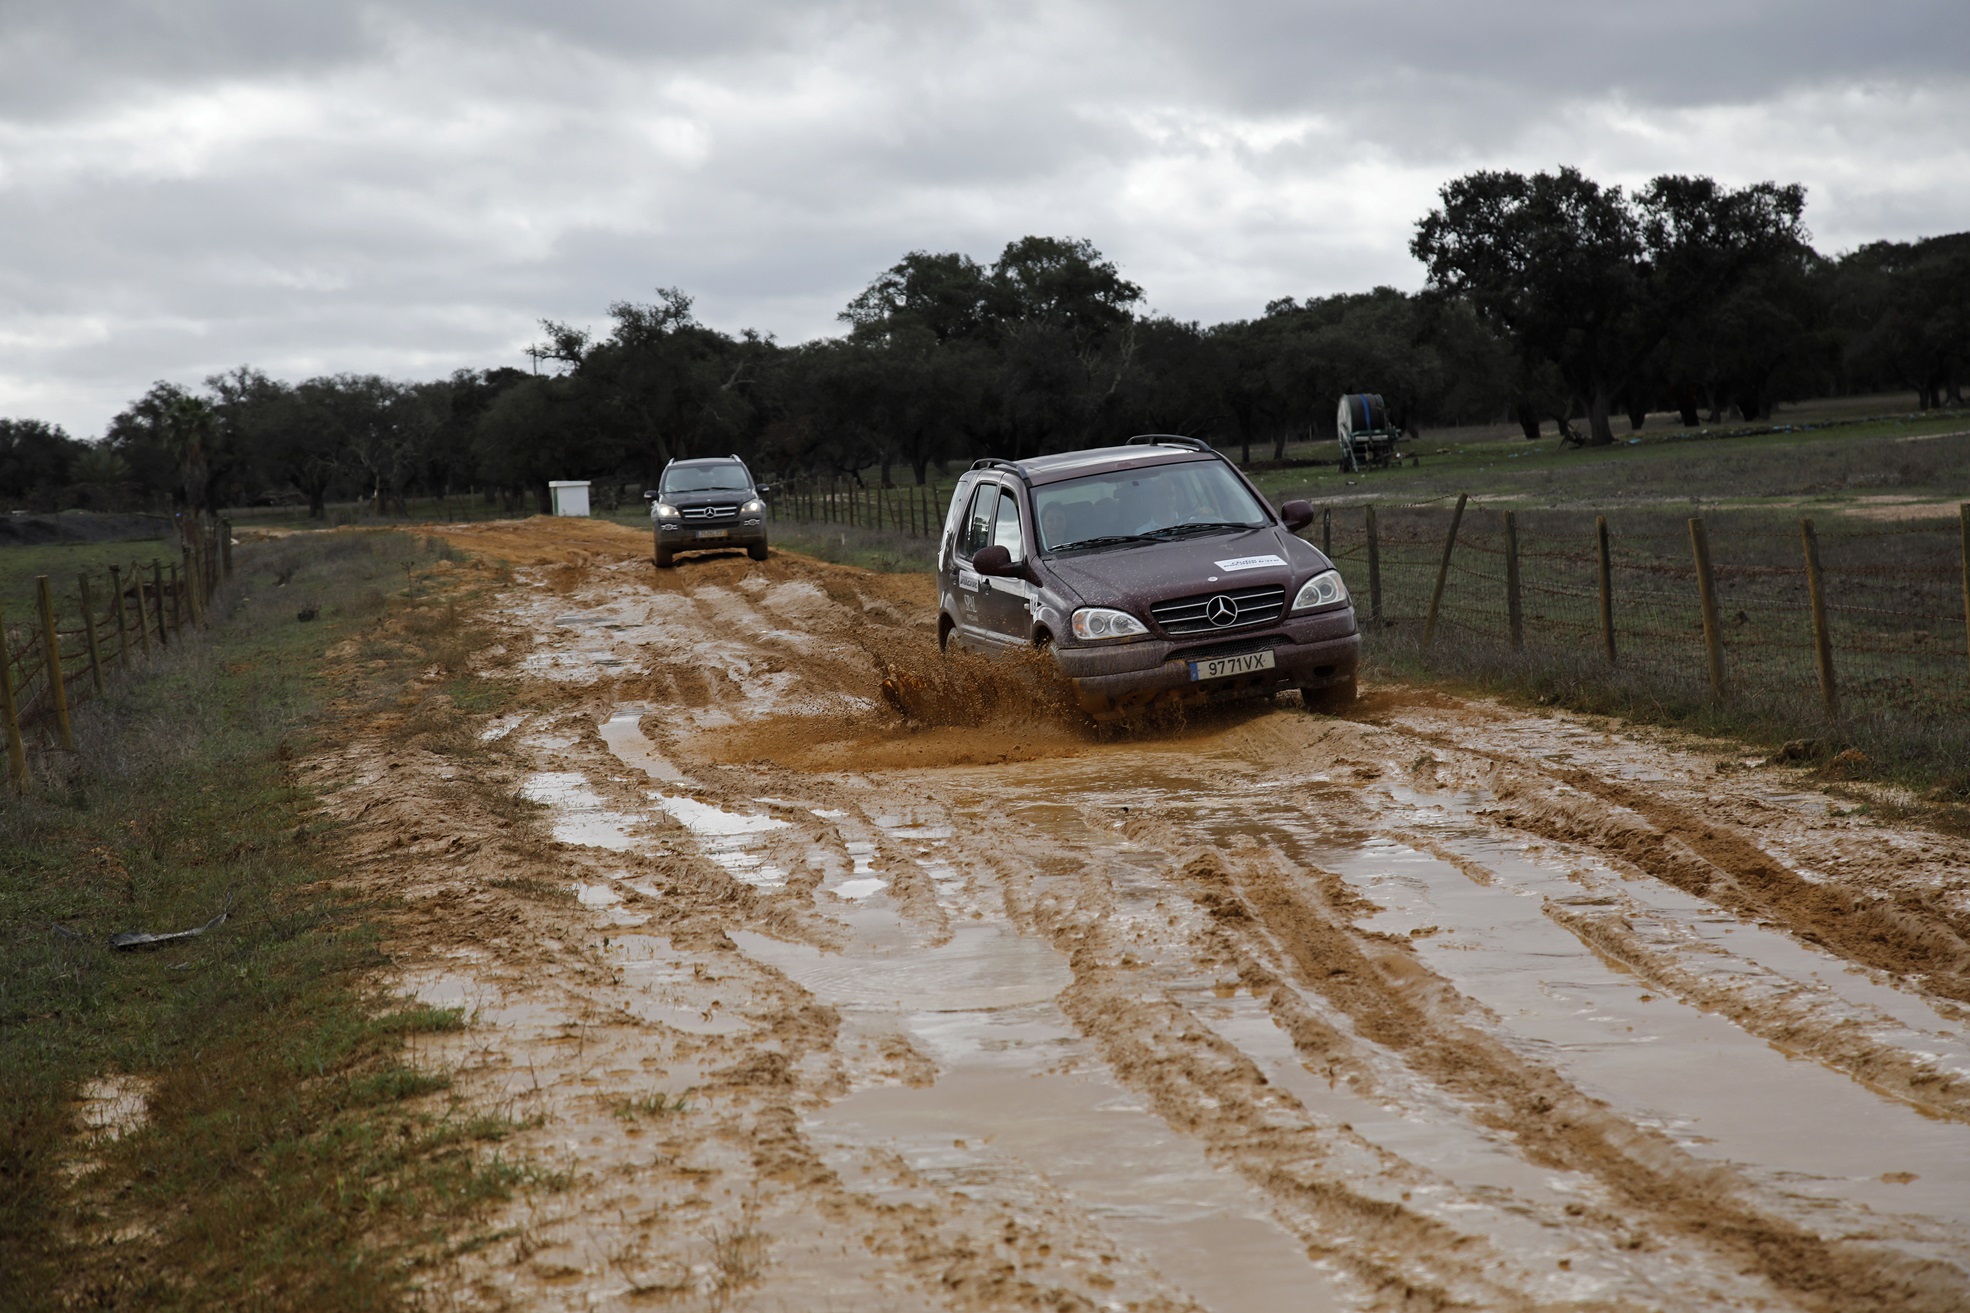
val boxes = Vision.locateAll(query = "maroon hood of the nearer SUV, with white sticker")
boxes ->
[1046,524,1330,613]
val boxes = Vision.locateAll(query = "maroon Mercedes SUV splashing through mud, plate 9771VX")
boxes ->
[938,434,1361,720]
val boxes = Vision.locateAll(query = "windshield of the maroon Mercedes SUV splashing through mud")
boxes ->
[1032,461,1267,552]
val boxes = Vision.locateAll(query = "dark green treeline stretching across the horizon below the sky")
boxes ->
[11,170,1970,515]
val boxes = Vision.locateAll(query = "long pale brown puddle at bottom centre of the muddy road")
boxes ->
[735,909,1344,1313]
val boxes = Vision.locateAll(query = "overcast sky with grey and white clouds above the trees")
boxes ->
[0,0,1970,436]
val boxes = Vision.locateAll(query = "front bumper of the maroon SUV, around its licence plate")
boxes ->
[1054,605,1361,716]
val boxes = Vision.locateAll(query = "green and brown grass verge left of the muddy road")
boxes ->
[0,534,528,1309]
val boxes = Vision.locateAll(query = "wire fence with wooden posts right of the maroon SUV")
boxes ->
[1308,497,1970,737]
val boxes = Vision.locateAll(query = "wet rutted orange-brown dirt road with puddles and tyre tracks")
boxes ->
[330,520,1970,1313]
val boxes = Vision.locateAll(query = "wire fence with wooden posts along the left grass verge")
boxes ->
[0,518,232,791]
